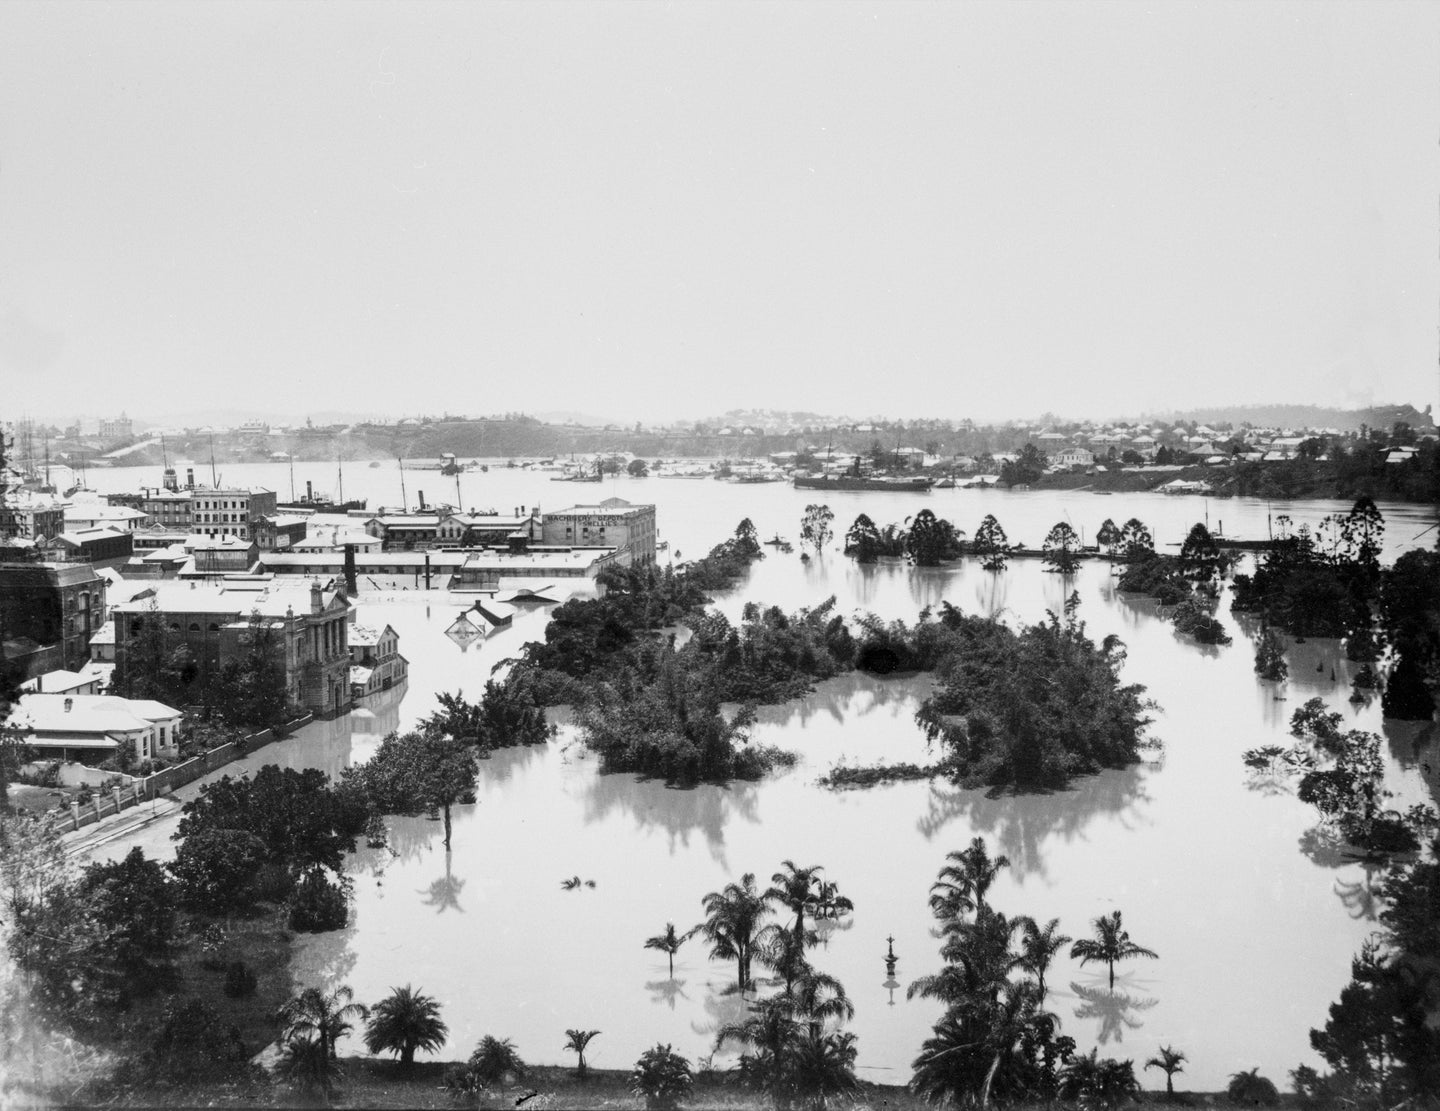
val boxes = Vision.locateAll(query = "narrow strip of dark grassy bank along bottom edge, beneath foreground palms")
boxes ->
[53,1058,1295,1111]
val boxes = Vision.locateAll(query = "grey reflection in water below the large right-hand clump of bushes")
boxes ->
[916,764,1152,879]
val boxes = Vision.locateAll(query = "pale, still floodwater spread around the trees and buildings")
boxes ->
[81,463,1440,1089]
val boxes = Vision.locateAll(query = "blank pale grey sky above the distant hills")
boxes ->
[0,0,1440,420]
